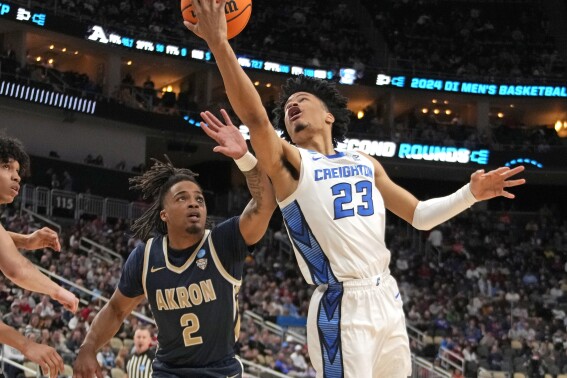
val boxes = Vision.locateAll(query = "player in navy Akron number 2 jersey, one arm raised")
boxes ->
[74,111,276,378]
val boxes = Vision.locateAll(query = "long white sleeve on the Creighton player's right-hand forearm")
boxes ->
[411,184,477,230]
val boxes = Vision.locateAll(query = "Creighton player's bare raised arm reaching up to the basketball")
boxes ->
[185,0,284,177]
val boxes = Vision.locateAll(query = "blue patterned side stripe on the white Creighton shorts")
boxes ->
[317,283,344,378]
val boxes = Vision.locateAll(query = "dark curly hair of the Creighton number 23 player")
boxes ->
[273,75,350,147]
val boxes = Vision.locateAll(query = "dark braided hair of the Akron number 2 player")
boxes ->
[128,155,200,240]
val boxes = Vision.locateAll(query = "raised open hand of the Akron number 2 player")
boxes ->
[201,109,248,159]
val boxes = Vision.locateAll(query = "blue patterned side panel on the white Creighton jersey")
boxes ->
[281,201,339,285]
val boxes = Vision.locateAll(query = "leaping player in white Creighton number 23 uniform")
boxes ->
[185,0,525,378]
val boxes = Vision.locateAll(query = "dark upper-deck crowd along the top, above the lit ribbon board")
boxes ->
[16,0,565,79]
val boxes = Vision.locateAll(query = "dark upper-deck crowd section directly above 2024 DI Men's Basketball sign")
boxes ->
[363,0,565,81]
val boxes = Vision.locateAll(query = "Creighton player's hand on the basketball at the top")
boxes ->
[183,0,228,47]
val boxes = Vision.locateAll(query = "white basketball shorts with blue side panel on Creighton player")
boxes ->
[307,273,411,378]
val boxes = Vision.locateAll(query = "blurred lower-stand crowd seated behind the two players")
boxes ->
[0,179,567,377]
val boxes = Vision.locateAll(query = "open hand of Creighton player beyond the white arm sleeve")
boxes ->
[470,166,526,201]
